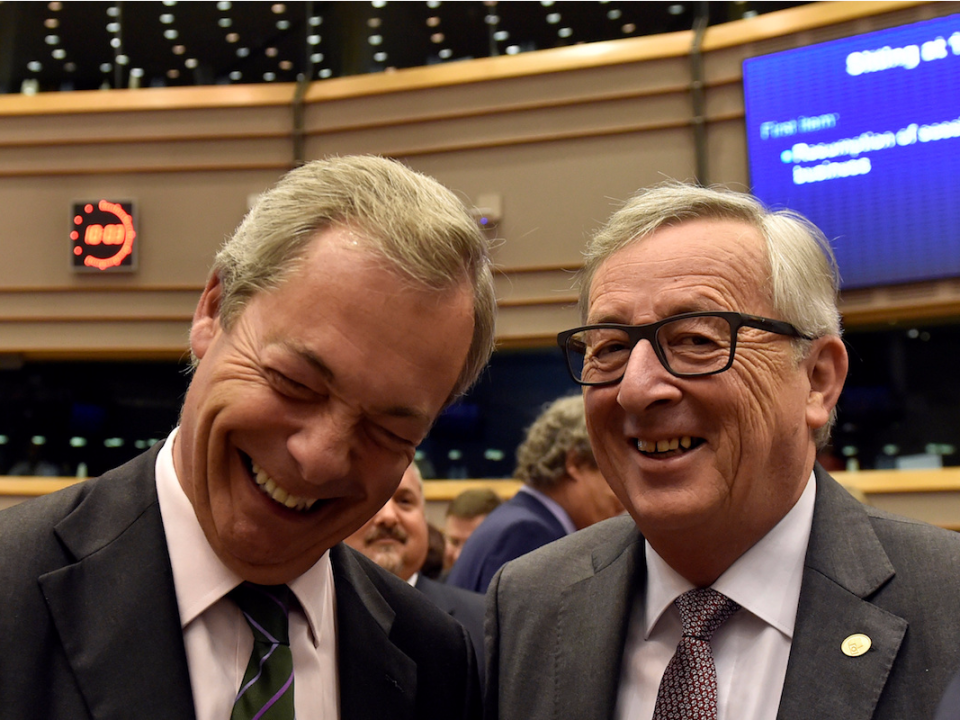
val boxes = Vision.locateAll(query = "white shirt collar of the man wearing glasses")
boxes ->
[644,473,816,638]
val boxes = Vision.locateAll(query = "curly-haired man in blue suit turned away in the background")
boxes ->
[447,395,623,592]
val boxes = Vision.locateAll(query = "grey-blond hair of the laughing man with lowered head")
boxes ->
[211,155,496,402]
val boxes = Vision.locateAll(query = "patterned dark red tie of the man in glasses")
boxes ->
[653,588,740,720]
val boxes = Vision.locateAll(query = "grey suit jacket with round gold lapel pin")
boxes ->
[486,467,960,720]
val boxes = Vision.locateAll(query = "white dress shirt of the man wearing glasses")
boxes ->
[615,473,816,720]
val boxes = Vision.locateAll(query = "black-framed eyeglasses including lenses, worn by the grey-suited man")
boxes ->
[557,311,813,385]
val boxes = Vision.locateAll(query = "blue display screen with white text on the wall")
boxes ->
[743,15,960,288]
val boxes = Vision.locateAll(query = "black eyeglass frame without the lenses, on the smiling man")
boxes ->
[557,310,816,387]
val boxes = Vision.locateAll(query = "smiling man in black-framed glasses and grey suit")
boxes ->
[487,183,960,720]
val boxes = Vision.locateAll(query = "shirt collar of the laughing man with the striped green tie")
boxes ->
[156,428,333,645]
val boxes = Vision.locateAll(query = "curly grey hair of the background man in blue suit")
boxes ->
[514,395,597,489]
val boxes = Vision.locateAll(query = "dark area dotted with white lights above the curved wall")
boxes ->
[0,0,809,93]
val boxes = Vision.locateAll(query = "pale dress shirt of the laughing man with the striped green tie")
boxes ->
[156,430,340,720]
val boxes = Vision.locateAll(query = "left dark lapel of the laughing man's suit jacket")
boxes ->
[40,447,194,720]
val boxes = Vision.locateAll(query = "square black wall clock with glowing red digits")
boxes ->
[70,200,137,272]
